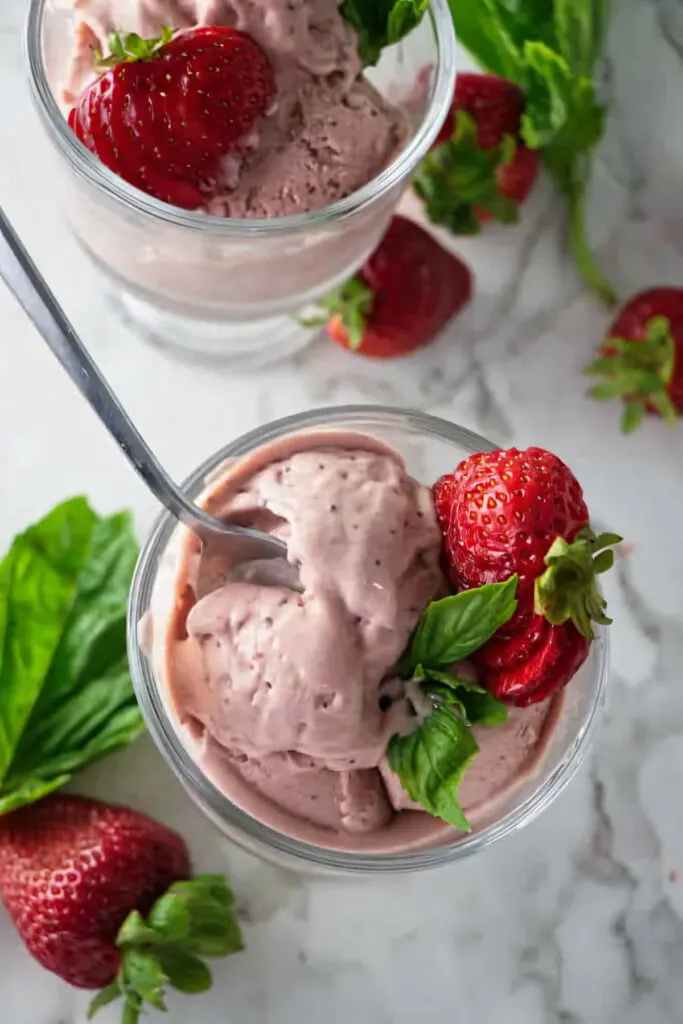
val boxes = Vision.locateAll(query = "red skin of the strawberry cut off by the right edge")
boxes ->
[604,288,683,414]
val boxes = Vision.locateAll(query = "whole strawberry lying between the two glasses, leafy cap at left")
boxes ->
[309,216,472,358]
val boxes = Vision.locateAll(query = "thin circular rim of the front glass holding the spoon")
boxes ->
[128,404,609,876]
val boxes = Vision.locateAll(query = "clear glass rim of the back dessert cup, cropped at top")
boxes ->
[24,0,457,239]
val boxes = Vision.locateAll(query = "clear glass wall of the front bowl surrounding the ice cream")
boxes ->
[128,407,607,876]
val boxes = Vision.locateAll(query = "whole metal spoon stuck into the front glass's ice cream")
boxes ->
[0,209,287,583]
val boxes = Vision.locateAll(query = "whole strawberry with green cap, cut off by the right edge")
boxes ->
[586,288,683,433]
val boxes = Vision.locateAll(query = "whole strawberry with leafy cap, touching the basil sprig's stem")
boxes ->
[414,72,540,234]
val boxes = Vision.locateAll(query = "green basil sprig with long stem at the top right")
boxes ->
[440,0,615,305]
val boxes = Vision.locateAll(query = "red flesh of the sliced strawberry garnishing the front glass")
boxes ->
[434,447,590,707]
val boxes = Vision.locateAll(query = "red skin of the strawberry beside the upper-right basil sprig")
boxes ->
[434,72,540,210]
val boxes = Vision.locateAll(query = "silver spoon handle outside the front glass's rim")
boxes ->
[0,209,211,529]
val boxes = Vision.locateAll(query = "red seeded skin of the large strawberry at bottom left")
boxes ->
[0,795,190,989]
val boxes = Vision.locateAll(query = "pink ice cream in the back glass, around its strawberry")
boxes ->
[65,0,411,218]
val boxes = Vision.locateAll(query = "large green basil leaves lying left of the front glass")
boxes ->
[0,499,143,813]
